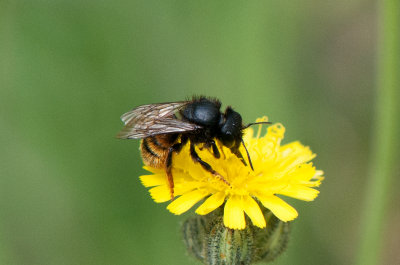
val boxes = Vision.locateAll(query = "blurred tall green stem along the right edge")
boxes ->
[356,0,400,265]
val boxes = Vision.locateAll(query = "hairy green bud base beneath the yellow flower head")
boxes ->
[182,207,290,265]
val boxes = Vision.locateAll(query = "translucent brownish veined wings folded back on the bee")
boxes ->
[117,101,202,139]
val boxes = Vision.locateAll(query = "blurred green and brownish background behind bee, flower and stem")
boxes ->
[0,0,400,265]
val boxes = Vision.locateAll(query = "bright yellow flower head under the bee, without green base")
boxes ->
[140,117,323,229]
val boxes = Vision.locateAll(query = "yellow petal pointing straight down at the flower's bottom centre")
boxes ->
[224,195,246,229]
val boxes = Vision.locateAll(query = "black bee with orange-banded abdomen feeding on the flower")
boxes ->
[117,96,269,200]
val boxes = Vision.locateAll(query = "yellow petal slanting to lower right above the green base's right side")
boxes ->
[259,196,298,222]
